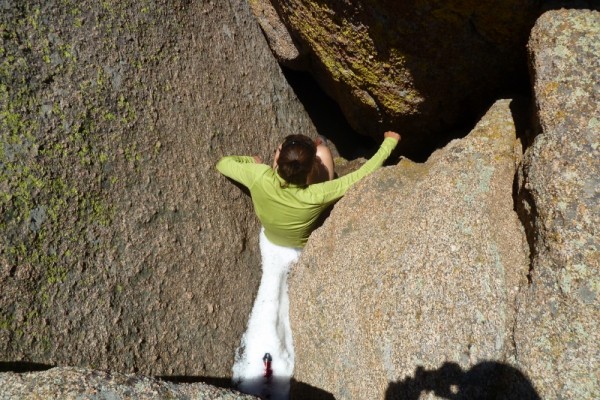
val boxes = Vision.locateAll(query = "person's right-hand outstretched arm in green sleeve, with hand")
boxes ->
[311,131,400,203]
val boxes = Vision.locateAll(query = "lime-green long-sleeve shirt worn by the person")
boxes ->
[217,138,398,247]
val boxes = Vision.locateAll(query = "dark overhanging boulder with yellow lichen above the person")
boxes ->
[251,0,539,147]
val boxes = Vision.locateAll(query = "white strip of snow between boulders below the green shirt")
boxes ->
[233,229,302,400]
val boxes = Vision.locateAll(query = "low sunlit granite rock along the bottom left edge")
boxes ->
[0,367,256,400]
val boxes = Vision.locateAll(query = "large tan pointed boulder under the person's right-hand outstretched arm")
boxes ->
[290,100,535,399]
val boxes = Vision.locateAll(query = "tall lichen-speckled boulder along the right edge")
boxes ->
[515,10,600,399]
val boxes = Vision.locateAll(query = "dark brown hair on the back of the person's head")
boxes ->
[277,135,317,186]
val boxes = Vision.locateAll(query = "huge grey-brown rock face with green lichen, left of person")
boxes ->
[0,0,314,376]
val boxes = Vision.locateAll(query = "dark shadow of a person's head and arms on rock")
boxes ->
[385,361,540,400]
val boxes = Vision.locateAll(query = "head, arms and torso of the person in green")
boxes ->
[217,132,399,248]
